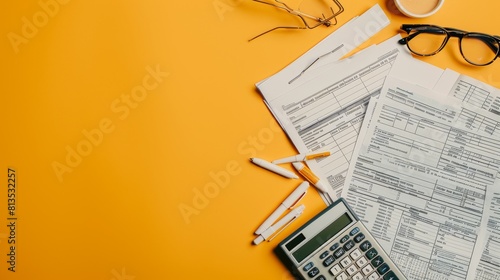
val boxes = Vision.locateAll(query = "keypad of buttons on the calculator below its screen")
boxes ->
[303,227,398,280]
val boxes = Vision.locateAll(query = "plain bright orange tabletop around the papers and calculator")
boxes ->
[0,0,500,280]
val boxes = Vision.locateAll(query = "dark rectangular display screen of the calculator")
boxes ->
[292,213,352,262]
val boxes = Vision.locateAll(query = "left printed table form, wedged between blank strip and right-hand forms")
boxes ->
[266,35,411,201]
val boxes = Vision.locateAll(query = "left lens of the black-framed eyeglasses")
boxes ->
[407,27,448,55]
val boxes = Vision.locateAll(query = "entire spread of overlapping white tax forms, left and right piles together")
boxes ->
[257,3,500,280]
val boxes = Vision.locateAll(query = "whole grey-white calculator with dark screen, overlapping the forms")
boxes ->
[274,198,406,280]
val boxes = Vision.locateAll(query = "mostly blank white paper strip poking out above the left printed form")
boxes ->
[257,4,390,100]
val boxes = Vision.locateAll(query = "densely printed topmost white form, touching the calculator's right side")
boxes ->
[342,77,500,280]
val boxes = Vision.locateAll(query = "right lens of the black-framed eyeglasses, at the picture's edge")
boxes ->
[460,33,499,65]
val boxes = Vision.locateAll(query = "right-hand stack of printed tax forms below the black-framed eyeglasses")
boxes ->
[342,68,500,280]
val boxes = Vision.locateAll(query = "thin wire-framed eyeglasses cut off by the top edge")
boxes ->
[248,0,344,41]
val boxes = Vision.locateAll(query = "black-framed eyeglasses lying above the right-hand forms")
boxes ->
[398,24,500,66]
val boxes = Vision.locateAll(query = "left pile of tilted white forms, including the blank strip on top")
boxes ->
[257,5,411,203]
